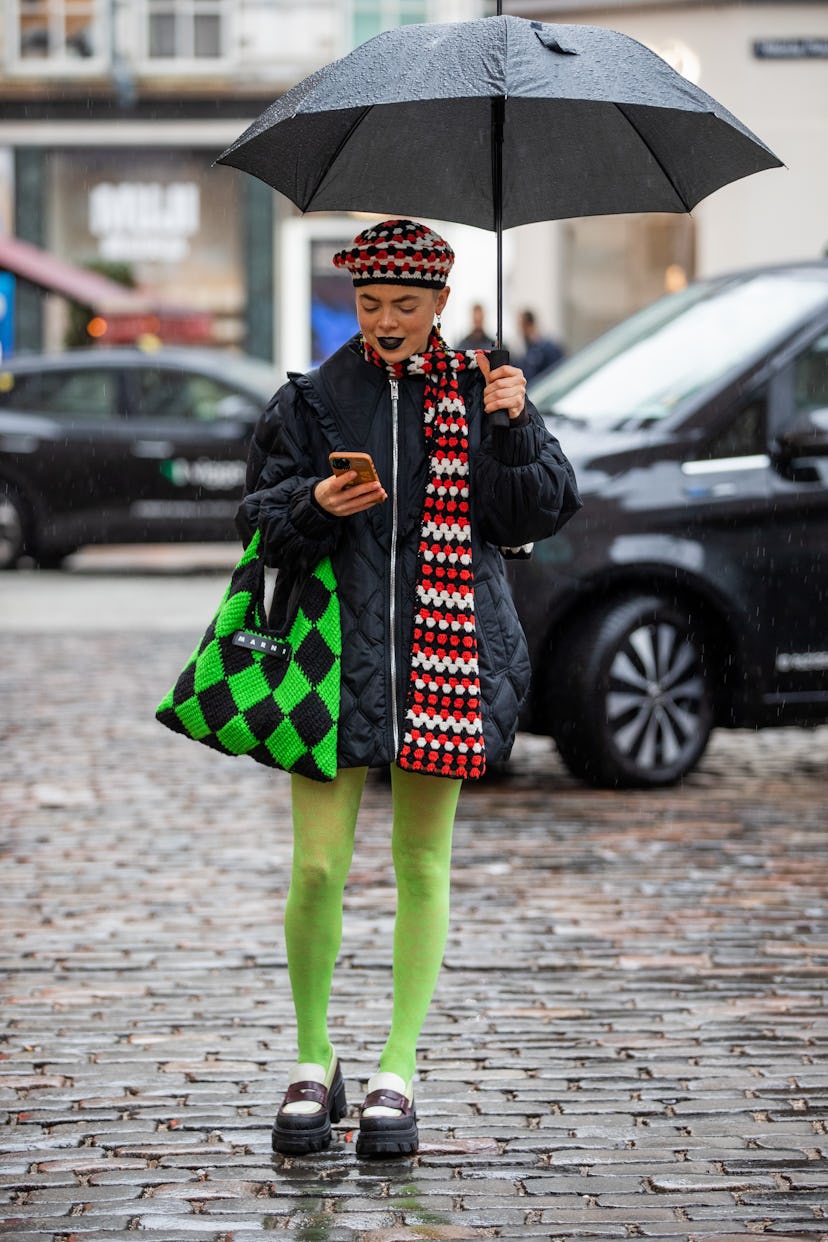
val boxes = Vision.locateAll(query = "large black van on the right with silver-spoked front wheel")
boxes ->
[511,262,828,786]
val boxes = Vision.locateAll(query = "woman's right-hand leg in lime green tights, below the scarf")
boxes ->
[380,766,462,1083]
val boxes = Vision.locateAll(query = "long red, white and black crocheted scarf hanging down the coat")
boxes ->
[362,329,485,780]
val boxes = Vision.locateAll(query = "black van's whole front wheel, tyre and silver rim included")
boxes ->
[549,596,714,787]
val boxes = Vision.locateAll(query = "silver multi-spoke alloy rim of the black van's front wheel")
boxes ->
[606,621,706,774]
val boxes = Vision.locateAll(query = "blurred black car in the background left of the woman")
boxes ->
[0,348,279,569]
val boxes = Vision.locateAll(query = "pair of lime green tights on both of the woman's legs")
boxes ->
[284,766,462,1082]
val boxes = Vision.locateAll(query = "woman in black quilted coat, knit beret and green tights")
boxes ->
[240,220,580,1156]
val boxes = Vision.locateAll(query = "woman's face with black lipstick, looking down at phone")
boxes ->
[356,283,449,363]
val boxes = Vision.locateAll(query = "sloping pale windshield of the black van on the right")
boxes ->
[529,273,828,427]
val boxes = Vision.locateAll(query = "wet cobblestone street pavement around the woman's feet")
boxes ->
[0,575,828,1242]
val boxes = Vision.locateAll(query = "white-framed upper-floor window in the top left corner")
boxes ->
[11,0,106,70]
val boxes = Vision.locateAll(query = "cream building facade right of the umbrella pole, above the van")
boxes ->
[508,0,828,348]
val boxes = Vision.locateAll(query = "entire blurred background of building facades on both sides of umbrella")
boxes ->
[0,0,828,368]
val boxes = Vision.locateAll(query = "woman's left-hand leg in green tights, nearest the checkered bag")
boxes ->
[284,768,367,1066]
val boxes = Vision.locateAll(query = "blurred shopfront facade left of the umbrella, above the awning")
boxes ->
[0,0,484,364]
